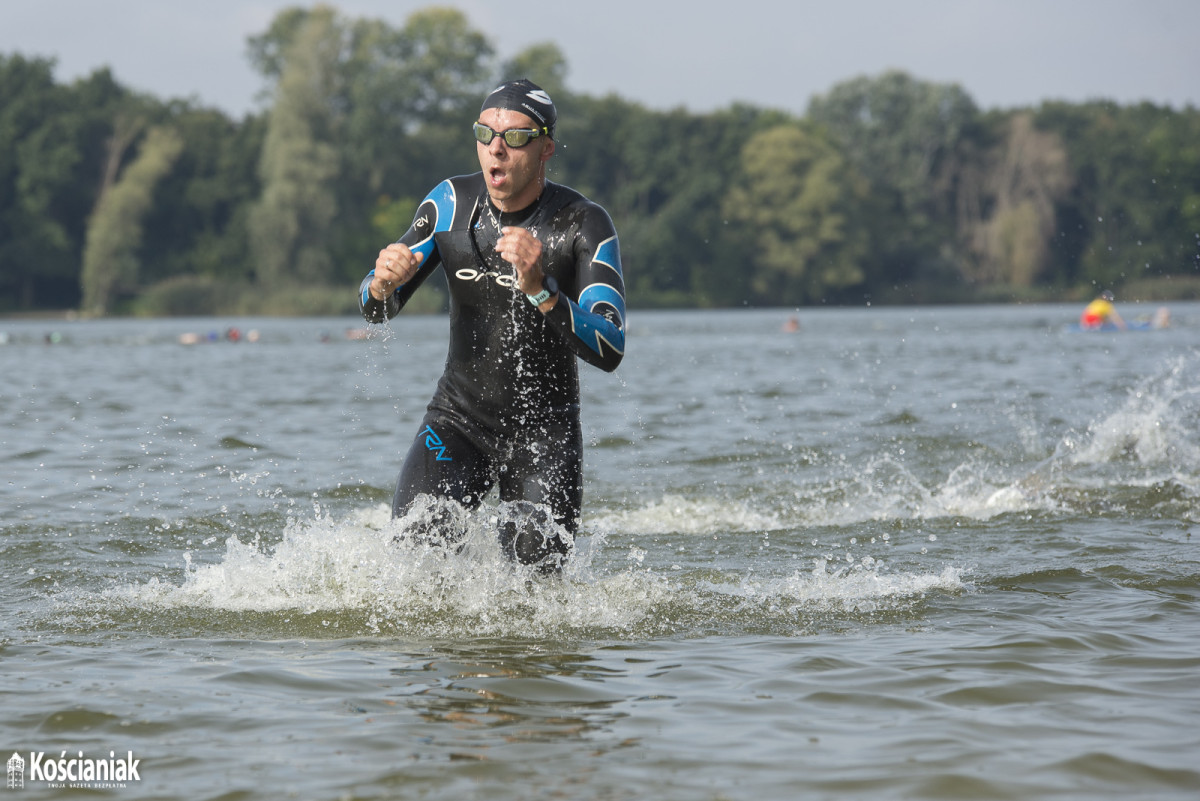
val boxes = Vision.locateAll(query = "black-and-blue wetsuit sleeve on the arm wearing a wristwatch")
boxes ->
[546,206,625,373]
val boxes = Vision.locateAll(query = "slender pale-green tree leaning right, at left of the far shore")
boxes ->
[82,126,182,315]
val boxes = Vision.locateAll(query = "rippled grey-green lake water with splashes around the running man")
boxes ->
[0,303,1200,801]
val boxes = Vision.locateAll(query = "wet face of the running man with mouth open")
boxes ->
[475,108,554,211]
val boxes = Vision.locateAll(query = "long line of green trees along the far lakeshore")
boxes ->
[0,6,1200,315]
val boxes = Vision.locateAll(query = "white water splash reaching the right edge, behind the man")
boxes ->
[775,356,1200,526]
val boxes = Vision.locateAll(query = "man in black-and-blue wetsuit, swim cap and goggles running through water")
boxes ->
[359,79,625,568]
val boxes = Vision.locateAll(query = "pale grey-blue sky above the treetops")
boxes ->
[0,0,1200,118]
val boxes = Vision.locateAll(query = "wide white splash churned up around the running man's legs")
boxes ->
[77,494,962,639]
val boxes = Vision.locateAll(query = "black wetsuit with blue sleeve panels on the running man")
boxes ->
[359,173,625,564]
